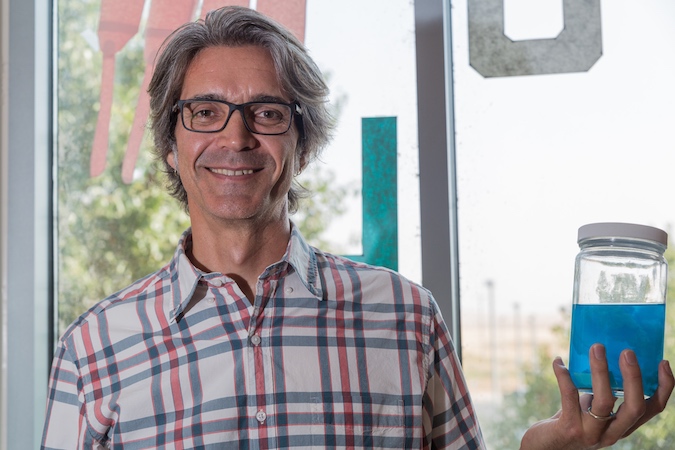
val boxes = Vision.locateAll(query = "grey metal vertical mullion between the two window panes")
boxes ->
[415,0,461,357]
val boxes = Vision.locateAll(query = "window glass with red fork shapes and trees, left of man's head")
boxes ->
[55,0,187,334]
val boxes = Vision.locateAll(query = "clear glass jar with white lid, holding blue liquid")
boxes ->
[569,223,668,396]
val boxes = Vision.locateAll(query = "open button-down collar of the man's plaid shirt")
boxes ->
[169,222,324,320]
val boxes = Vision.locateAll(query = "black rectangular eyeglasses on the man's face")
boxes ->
[174,100,302,136]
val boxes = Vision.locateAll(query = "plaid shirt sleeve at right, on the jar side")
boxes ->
[424,299,486,450]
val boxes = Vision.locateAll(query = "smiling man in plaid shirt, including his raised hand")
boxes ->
[43,7,675,449]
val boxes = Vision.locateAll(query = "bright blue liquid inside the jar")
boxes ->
[569,303,666,396]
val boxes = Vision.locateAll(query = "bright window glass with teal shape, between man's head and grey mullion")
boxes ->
[300,0,421,282]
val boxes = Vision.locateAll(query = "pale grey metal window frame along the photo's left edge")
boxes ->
[0,0,54,448]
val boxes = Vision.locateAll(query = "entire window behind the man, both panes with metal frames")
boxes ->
[14,0,675,449]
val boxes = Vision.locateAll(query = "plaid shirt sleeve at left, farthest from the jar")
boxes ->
[41,341,92,450]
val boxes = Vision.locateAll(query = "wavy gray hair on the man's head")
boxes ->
[148,6,333,213]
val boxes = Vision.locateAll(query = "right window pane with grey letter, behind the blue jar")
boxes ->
[452,0,675,449]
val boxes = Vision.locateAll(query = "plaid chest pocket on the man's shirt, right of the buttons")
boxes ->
[311,394,410,449]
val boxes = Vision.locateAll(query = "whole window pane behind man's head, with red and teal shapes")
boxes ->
[55,0,421,335]
